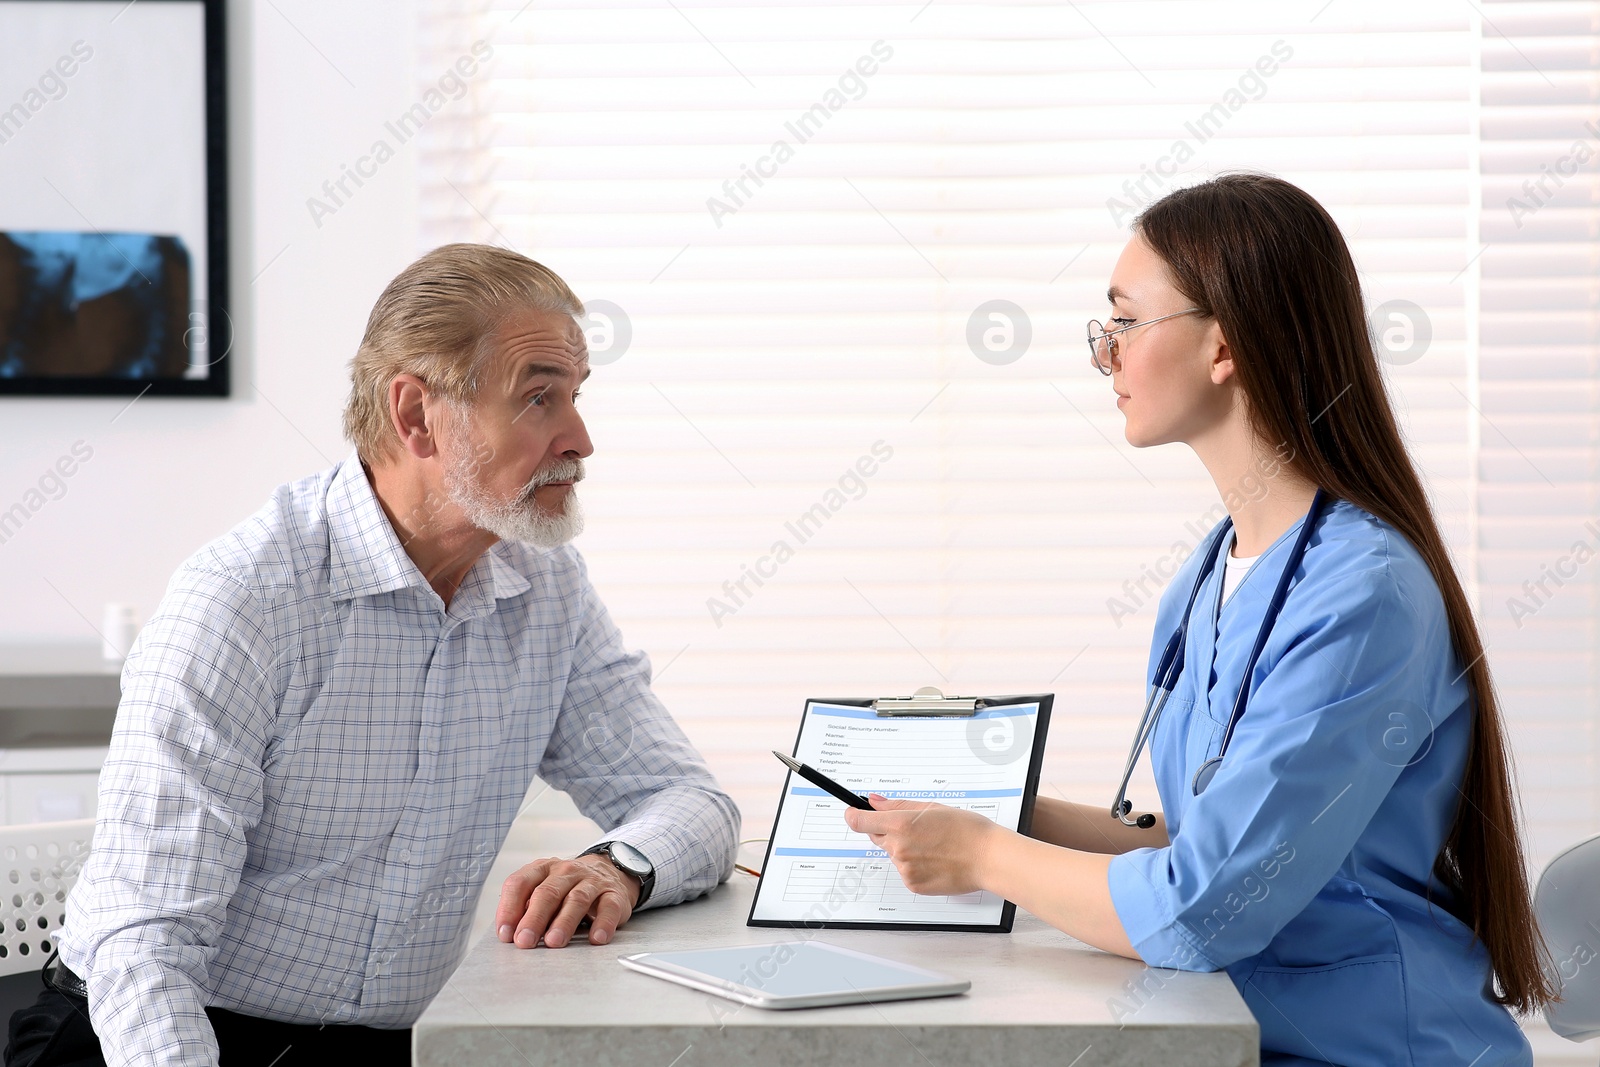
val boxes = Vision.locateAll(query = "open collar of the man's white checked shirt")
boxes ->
[328,451,530,603]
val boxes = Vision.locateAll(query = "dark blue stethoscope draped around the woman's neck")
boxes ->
[1110,488,1328,830]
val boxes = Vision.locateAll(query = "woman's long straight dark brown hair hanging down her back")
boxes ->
[1134,174,1557,1013]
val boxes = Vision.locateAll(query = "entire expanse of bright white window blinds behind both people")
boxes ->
[419,0,1600,985]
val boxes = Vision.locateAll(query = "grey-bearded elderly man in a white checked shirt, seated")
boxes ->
[8,245,739,1067]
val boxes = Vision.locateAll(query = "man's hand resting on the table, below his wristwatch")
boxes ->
[494,854,638,949]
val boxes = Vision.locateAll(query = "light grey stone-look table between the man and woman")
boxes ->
[413,873,1259,1067]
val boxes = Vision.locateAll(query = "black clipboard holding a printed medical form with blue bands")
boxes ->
[746,688,1054,933]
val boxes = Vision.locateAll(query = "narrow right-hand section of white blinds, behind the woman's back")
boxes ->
[1475,2,1600,1064]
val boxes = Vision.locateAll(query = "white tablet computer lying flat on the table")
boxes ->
[618,941,973,1009]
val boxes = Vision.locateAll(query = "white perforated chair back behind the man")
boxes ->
[0,819,94,976]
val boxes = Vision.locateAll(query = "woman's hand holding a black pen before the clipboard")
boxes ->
[845,793,1005,896]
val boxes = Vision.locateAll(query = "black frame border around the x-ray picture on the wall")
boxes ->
[0,0,234,397]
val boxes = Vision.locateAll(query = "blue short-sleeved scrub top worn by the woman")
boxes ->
[1110,501,1533,1067]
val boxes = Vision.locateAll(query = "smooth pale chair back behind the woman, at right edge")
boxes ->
[1533,837,1600,1041]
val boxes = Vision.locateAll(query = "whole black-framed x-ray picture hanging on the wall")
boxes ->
[0,0,232,397]
